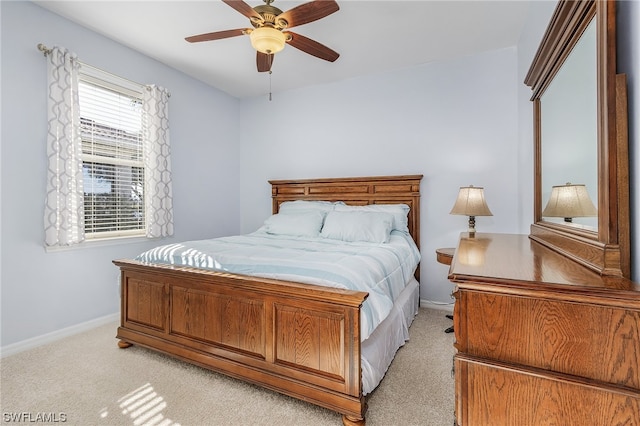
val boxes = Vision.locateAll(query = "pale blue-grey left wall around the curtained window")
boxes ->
[0,2,240,347]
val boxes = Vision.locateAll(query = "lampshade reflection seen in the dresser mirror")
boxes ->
[542,182,598,222]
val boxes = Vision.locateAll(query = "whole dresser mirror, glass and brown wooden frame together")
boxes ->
[525,0,631,278]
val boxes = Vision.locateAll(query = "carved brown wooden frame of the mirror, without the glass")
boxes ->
[525,0,631,278]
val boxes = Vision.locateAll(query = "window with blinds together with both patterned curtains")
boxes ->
[44,47,173,248]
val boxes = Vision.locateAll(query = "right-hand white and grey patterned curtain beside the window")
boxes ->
[142,85,173,238]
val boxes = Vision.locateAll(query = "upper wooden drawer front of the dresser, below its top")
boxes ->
[455,290,640,389]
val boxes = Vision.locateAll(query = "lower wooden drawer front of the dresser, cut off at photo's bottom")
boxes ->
[455,355,640,426]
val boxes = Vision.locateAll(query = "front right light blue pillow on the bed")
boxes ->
[320,211,393,243]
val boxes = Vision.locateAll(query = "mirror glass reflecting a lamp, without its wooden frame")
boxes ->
[540,19,598,231]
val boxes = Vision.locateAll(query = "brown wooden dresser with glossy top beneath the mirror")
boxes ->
[449,233,640,426]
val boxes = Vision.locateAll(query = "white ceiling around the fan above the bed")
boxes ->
[34,0,529,98]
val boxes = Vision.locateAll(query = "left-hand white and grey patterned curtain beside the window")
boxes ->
[44,47,84,246]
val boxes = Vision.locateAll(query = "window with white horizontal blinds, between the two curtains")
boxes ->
[78,64,146,239]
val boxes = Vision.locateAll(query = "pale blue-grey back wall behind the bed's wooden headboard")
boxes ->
[240,48,529,303]
